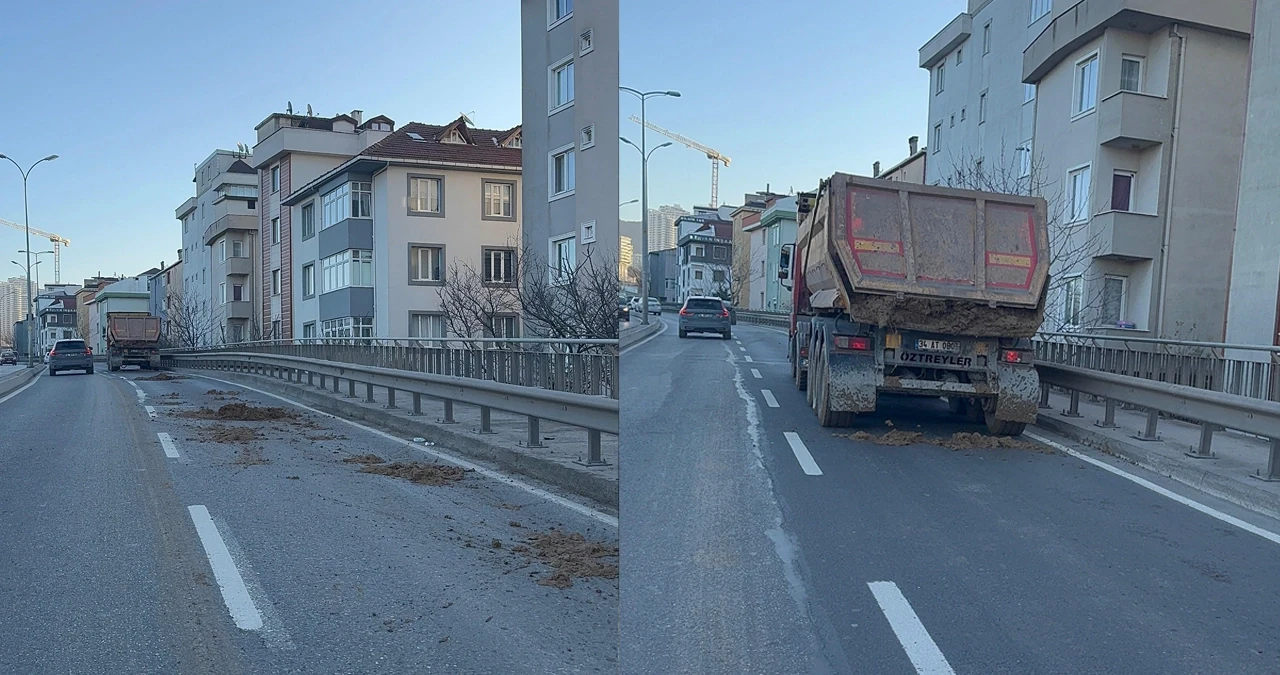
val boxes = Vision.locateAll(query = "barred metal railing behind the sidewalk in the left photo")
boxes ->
[161,338,618,400]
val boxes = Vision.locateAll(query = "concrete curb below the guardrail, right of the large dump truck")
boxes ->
[1036,412,1280,517]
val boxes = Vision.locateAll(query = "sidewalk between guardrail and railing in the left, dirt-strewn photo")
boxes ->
[174,369,618,508]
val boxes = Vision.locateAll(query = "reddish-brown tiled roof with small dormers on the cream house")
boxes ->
[361,119,521,169]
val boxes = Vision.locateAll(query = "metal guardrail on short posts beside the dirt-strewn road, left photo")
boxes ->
[161,351,618,466]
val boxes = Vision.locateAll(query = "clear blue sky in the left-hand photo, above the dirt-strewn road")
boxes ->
[0,0,519,288]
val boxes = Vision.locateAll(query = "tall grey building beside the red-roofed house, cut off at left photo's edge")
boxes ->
[521,0,620,288]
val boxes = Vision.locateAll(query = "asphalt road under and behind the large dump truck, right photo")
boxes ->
[620,318,1280,675]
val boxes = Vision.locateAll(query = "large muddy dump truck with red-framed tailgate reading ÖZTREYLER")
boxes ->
[780,173,1050,435]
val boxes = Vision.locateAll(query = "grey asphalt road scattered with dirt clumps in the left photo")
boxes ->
[0,371,618,674]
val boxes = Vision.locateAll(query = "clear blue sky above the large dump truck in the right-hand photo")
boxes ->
[624,0,966,220]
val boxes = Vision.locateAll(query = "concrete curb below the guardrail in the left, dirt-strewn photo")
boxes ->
[177,369,618,510]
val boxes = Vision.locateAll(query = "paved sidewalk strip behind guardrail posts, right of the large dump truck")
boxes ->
[1037,391,1280,517]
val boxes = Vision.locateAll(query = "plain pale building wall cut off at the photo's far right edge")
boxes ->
[1226,0,1280,350]
